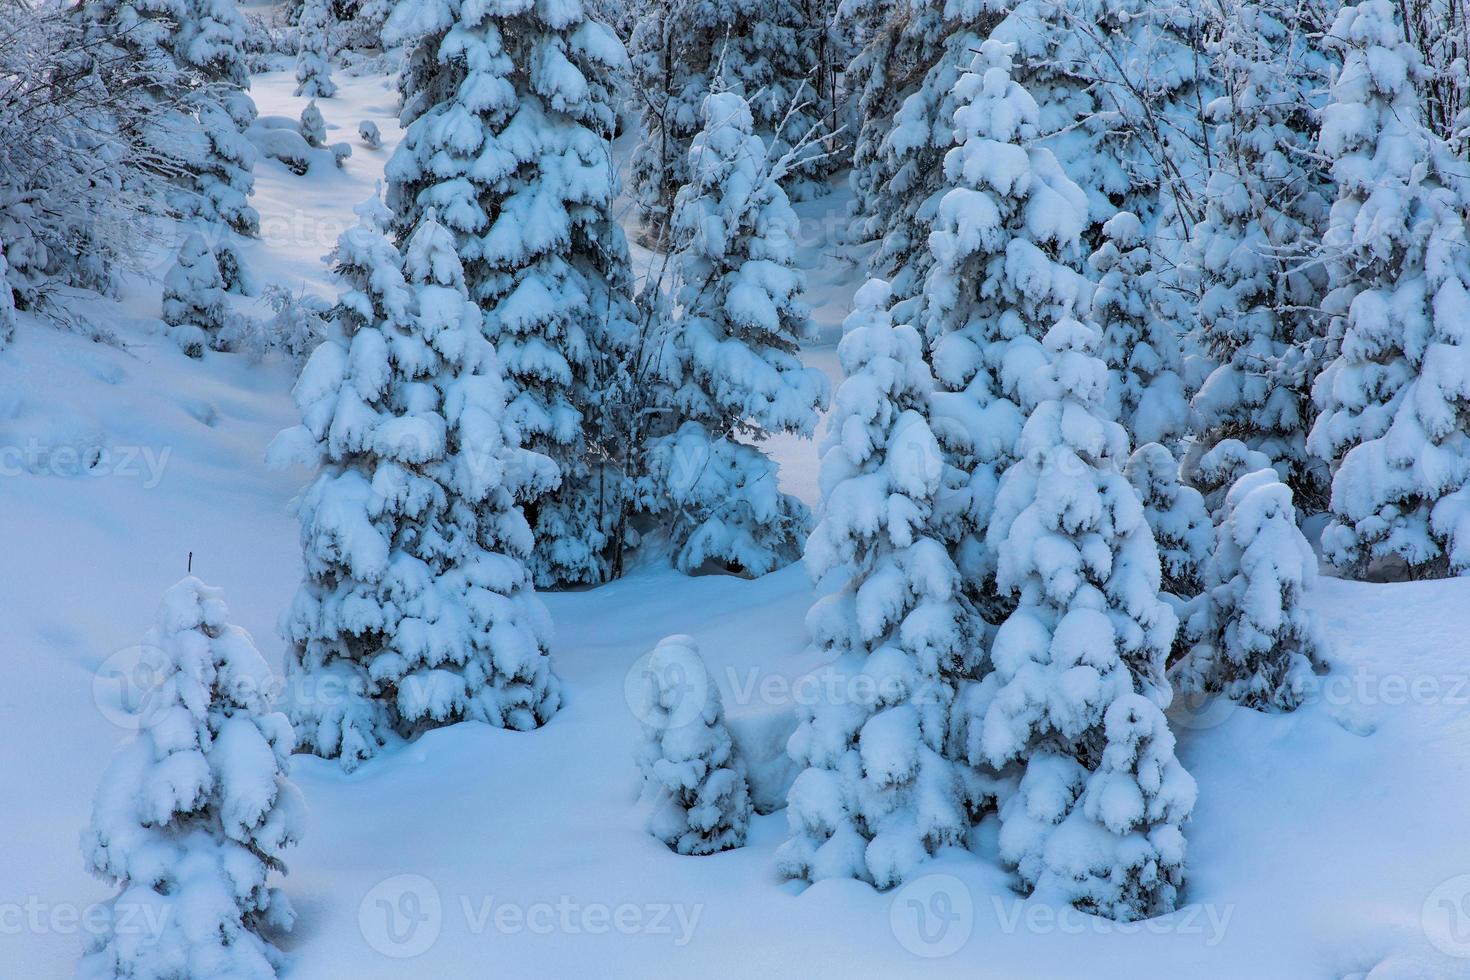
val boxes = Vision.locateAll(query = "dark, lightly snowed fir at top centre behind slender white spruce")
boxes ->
[629,0,833,241]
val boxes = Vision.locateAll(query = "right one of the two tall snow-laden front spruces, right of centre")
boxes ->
[966,319,1195,920]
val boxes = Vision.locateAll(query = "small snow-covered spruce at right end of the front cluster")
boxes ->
[1176,469,1327,711]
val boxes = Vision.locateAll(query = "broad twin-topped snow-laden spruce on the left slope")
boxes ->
[272,201,560,768]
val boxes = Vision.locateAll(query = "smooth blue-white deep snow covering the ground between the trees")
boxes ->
[0,65,1470,980]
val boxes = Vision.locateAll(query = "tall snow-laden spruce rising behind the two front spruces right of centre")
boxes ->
[929,41,1092,620]
